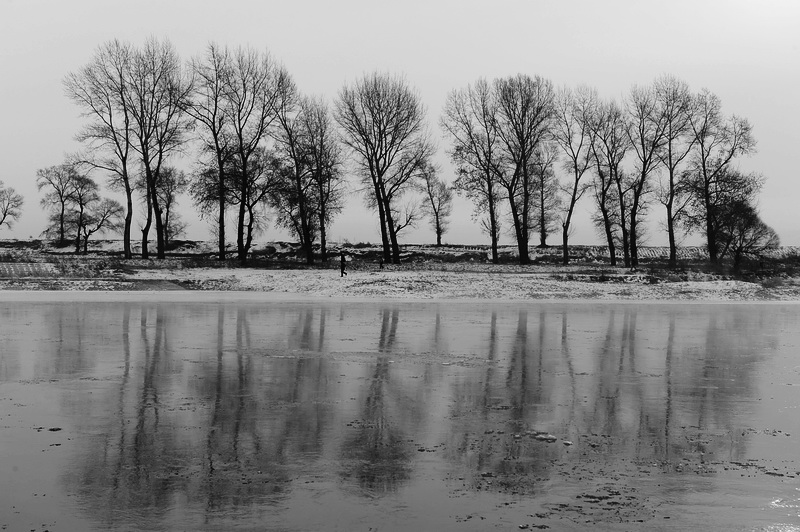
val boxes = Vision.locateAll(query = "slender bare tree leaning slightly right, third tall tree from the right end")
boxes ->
[626,81,667,268]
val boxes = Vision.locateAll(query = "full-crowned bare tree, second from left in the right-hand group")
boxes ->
[494,74,554,264]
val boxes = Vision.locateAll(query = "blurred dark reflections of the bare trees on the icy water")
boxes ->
[0,303,797,527]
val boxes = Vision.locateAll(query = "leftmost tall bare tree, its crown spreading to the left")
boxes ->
[59,40,134,259]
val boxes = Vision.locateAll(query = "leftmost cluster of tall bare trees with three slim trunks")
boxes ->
[64,39,192,258]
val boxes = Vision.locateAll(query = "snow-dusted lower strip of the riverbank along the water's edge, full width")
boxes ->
[0,268,800,301]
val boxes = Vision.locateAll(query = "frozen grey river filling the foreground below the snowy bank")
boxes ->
[0,292,800,532]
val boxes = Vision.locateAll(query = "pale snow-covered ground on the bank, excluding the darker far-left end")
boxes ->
[117,268,800,301]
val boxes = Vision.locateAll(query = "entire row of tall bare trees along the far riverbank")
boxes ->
[51,35,777,267]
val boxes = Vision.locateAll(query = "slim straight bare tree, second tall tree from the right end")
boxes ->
[655,76,694,267]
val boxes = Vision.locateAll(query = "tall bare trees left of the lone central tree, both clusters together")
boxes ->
[64,39,343,263]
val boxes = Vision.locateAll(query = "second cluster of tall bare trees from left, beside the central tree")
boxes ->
[186,44,343,264]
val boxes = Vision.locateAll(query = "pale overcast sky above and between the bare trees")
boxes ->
[0,0,800,245]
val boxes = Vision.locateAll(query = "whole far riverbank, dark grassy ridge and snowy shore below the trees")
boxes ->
[0,241,800,302]
